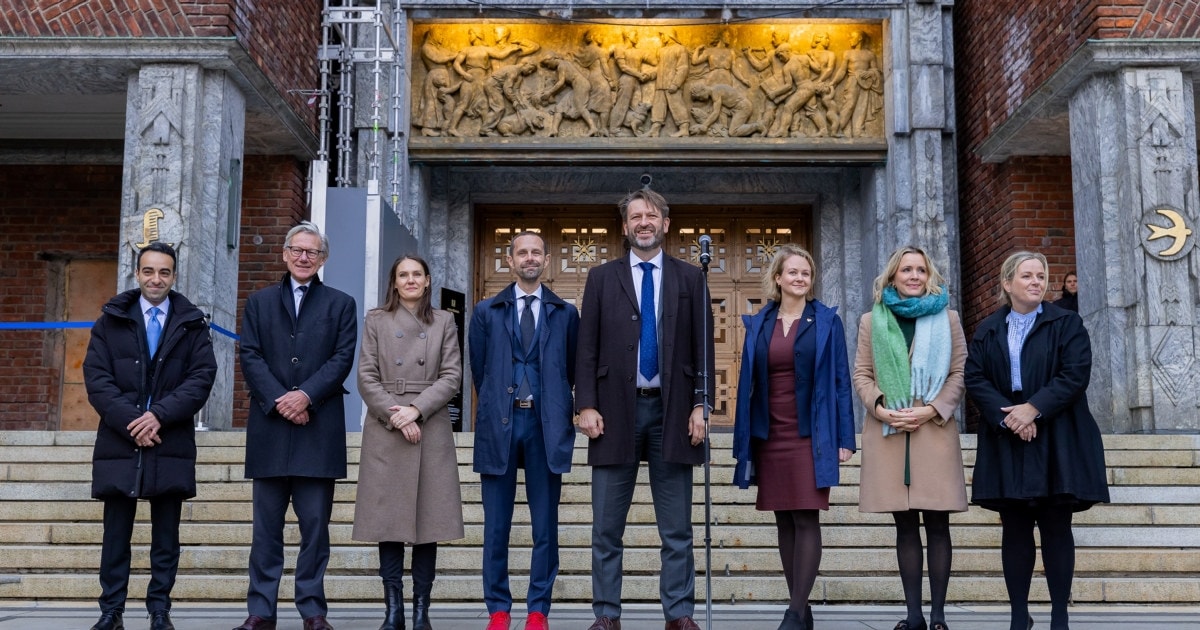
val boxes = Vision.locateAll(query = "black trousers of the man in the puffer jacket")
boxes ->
[100,497,184,612]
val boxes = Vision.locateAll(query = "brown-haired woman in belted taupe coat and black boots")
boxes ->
[353,256,463,630]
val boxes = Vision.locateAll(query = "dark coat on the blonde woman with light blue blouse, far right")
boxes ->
[964,302,1109,511]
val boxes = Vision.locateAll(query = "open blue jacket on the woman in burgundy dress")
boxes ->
[733,300,857,487]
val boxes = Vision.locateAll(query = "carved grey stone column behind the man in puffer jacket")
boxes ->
[118,64,246,428]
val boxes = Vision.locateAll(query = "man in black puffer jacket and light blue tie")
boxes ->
[83,242,217,630]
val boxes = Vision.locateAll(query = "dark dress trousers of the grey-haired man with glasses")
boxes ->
[246,476,334,619]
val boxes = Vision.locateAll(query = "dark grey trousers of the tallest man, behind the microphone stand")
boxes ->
[592,396,696,620]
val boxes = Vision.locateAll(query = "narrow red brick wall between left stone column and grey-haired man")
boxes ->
[233,156,308,427]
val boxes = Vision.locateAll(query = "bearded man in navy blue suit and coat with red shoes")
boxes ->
[468,232,580,630]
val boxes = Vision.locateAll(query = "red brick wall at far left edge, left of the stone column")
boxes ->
[0,166,121,430]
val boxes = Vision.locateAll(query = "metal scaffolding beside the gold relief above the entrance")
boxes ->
[310,0,408,223]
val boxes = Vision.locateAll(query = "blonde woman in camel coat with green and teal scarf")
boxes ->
[854,246,967,630]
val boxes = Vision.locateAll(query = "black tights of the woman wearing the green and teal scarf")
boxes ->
[892,510,953,628]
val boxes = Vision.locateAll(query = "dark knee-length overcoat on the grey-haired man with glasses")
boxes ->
[240,275,358,479]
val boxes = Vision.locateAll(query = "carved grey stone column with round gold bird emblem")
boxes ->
[1070,67,1200,433]
